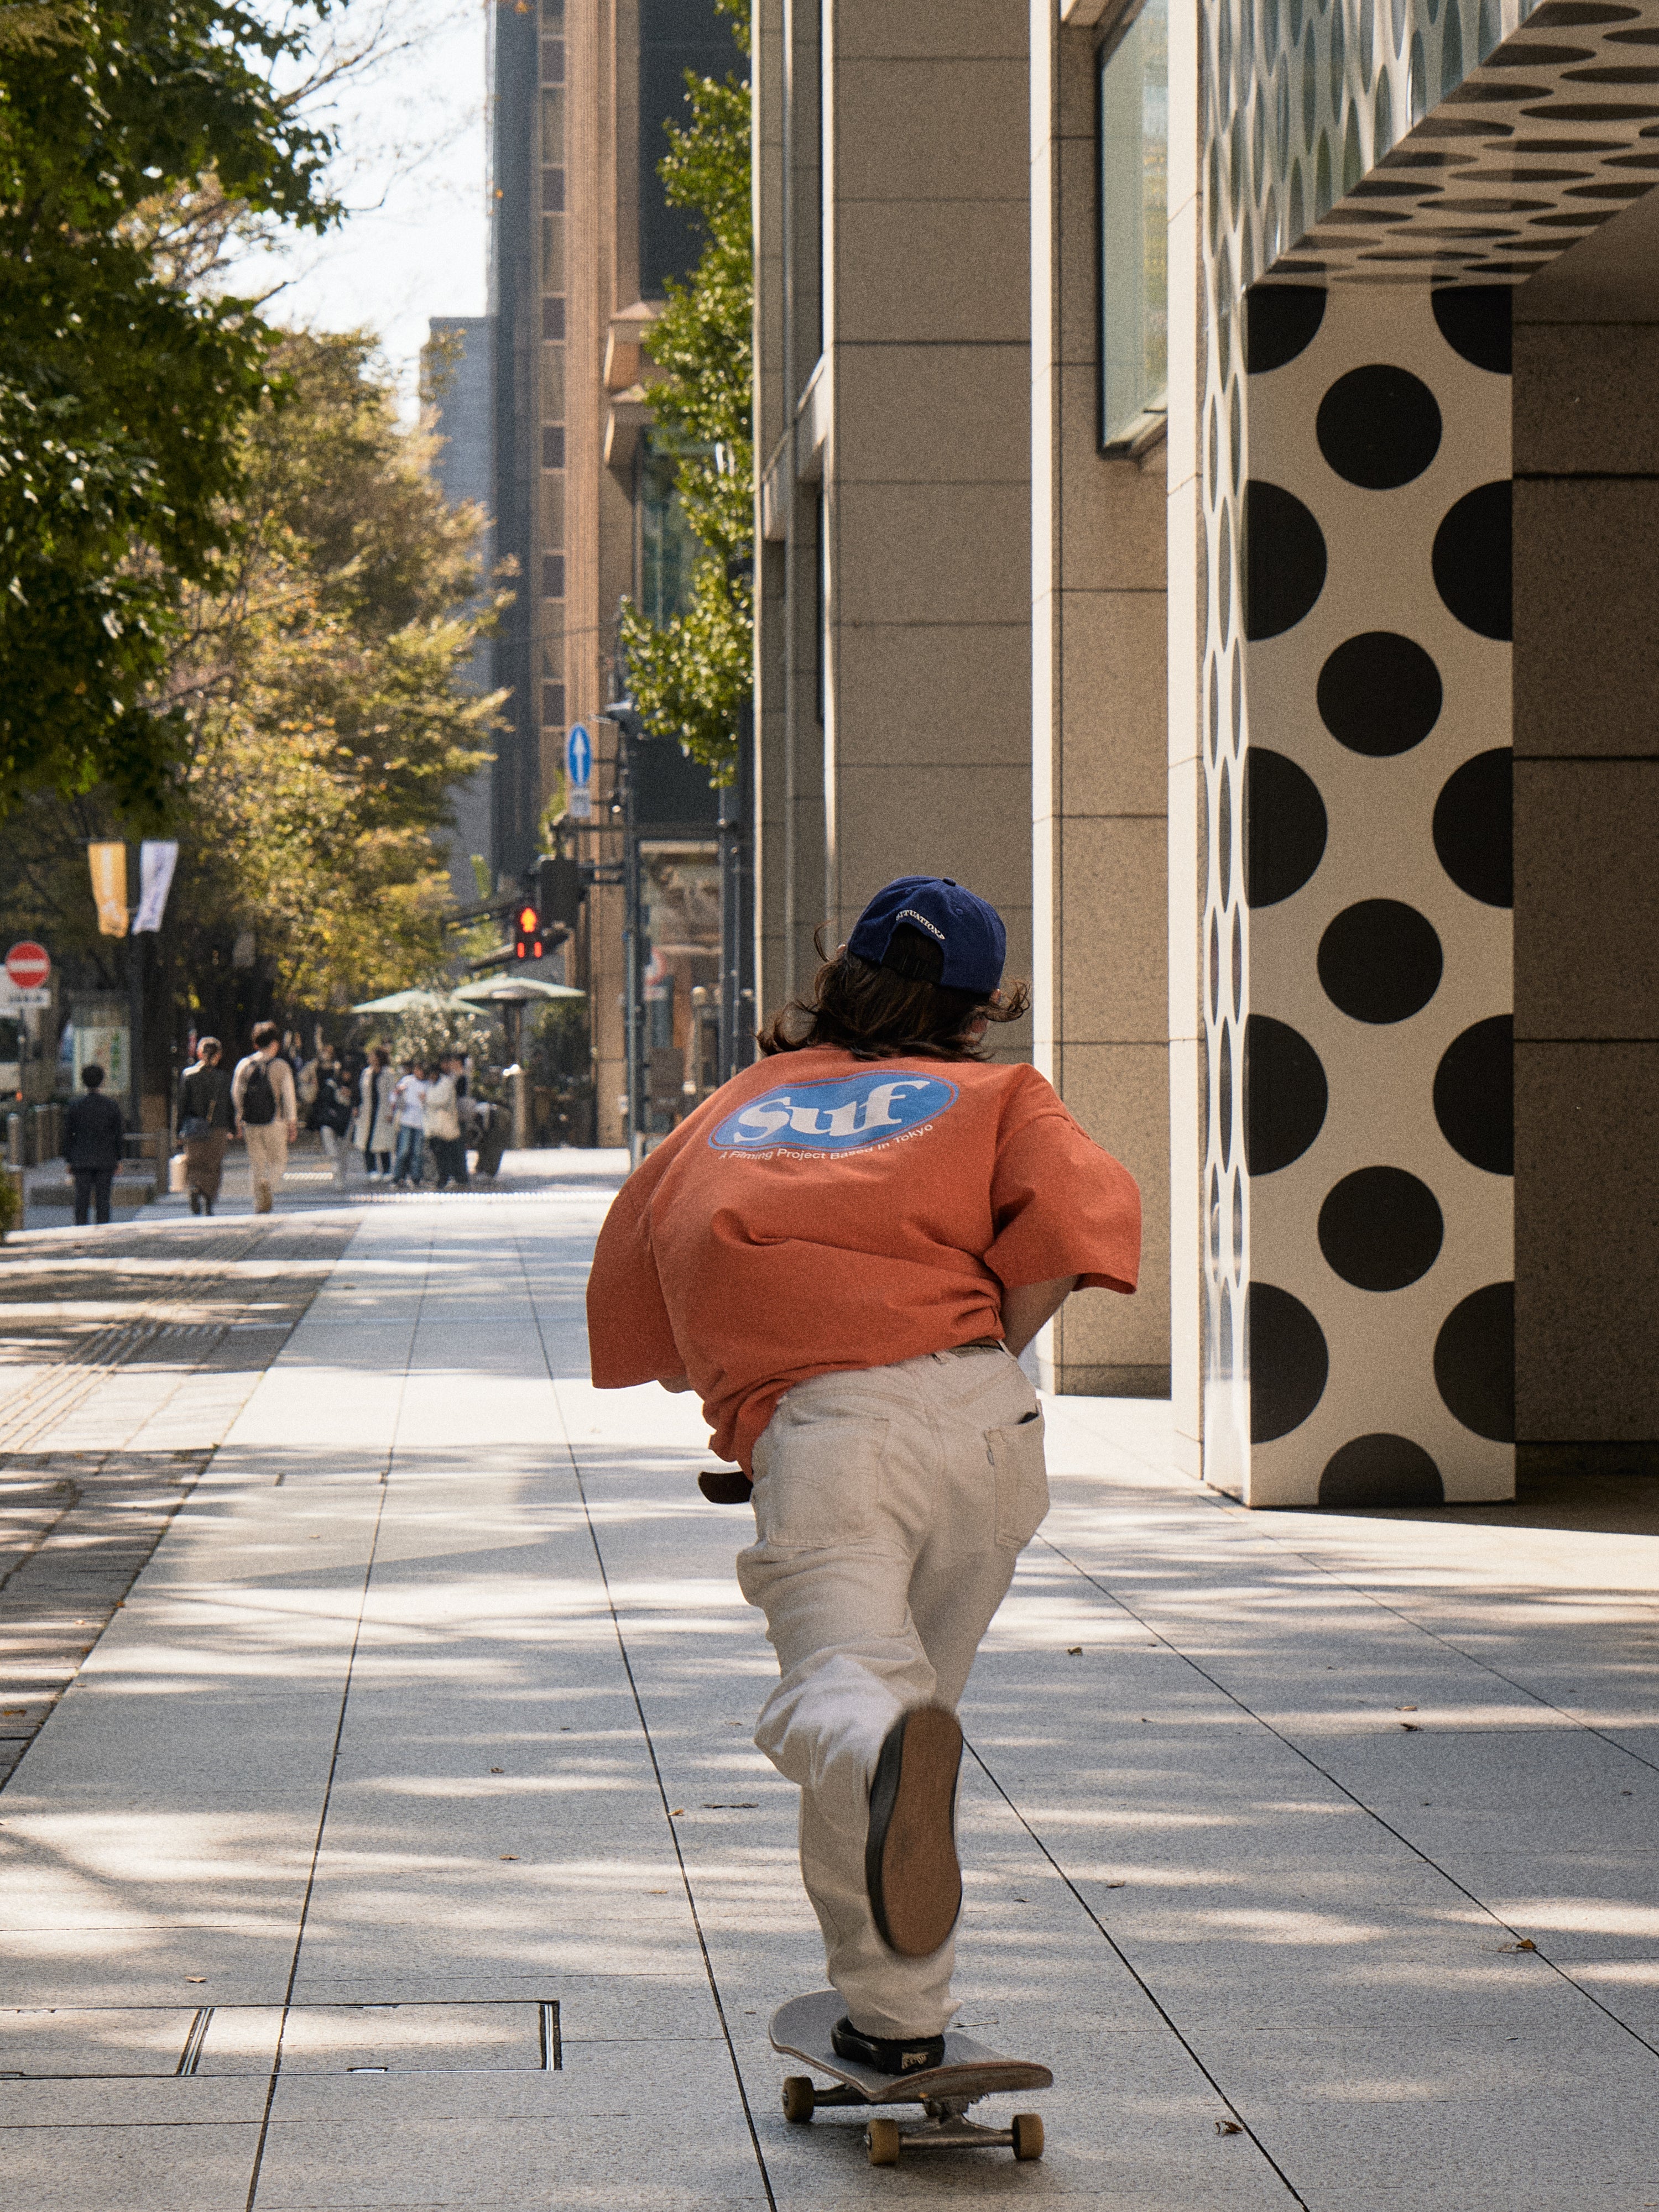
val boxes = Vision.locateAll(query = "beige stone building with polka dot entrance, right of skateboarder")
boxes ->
[757,0,1659,1504]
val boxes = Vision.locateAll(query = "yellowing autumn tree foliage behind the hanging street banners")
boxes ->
[0,334,500,1037]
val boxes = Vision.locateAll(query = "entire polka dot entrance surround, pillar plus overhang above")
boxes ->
[1197,0,1659,1504]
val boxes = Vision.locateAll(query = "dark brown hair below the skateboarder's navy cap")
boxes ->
[754,922,1031,1059]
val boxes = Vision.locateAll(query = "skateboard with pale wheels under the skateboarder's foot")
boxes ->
[772,1989,1055,2166]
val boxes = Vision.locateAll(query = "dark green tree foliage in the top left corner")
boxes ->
[0,0,334,816]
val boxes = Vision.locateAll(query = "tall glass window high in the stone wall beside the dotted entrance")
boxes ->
[1097,0,1170,453]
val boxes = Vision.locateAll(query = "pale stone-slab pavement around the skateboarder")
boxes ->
[0,1179,1659,2212]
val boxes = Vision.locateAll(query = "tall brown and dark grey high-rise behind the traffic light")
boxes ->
[489,0,743,1144]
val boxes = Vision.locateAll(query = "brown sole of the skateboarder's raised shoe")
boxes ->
[865,1706,962,1958]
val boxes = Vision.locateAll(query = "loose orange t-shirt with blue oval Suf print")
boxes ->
[588,1044,1141,1469]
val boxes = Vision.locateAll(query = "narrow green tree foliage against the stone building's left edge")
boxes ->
[622,0,754,778]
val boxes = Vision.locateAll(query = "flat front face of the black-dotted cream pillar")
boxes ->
[1241,287,1513,1504]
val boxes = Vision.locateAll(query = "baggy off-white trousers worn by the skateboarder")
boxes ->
[737,1347,1048,2035]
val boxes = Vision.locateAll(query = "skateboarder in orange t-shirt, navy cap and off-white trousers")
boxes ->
[588,876,1141,2075]
